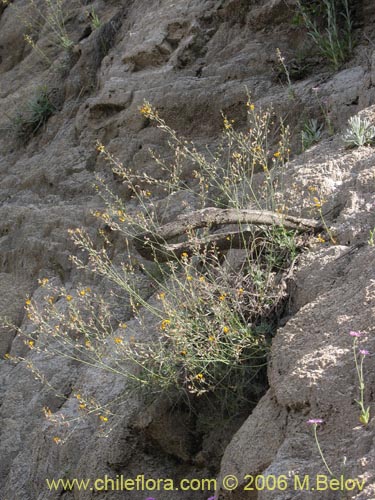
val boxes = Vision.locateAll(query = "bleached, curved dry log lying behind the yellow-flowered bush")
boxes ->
[134,208,323,262]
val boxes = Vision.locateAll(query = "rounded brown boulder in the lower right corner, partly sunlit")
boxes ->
[221,247,375,499]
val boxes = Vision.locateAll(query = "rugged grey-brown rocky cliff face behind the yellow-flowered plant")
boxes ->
[0,0,375,500]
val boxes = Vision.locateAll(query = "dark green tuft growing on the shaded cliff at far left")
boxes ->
[11,86,56,142]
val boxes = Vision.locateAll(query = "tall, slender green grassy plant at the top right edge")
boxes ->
[297,0,353,70]
